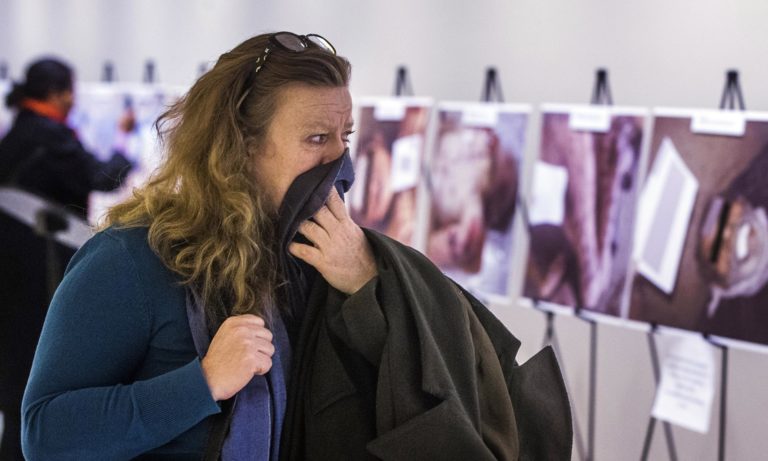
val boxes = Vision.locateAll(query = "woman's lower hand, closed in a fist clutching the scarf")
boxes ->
[201,314,275,401]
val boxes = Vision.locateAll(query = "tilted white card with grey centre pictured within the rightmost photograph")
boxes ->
[634,138,699,294]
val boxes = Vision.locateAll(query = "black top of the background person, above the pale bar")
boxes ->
[0,109,131,218]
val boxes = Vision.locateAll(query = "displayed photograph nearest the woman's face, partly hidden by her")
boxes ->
[349,98,432,245]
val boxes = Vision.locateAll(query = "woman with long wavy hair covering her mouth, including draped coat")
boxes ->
[23,32,570,460]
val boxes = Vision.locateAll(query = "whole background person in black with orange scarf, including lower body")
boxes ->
[0,59,133,461]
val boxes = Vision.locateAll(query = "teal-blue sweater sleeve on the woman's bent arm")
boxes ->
[22,233,220,461]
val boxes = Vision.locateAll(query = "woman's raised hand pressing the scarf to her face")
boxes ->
[288,187,378,294]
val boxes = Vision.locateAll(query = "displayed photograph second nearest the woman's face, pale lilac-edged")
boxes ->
[426,103,529,295]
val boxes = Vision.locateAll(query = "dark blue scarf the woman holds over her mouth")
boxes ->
[187,150,354,461]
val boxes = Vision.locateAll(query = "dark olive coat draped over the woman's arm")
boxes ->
[281,231,572,460]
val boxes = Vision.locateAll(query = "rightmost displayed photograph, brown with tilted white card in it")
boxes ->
[629,109,768,344]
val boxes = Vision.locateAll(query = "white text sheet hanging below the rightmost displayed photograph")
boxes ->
[651,335,715,434]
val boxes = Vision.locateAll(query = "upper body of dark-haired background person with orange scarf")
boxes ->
[0,58,134,219]
